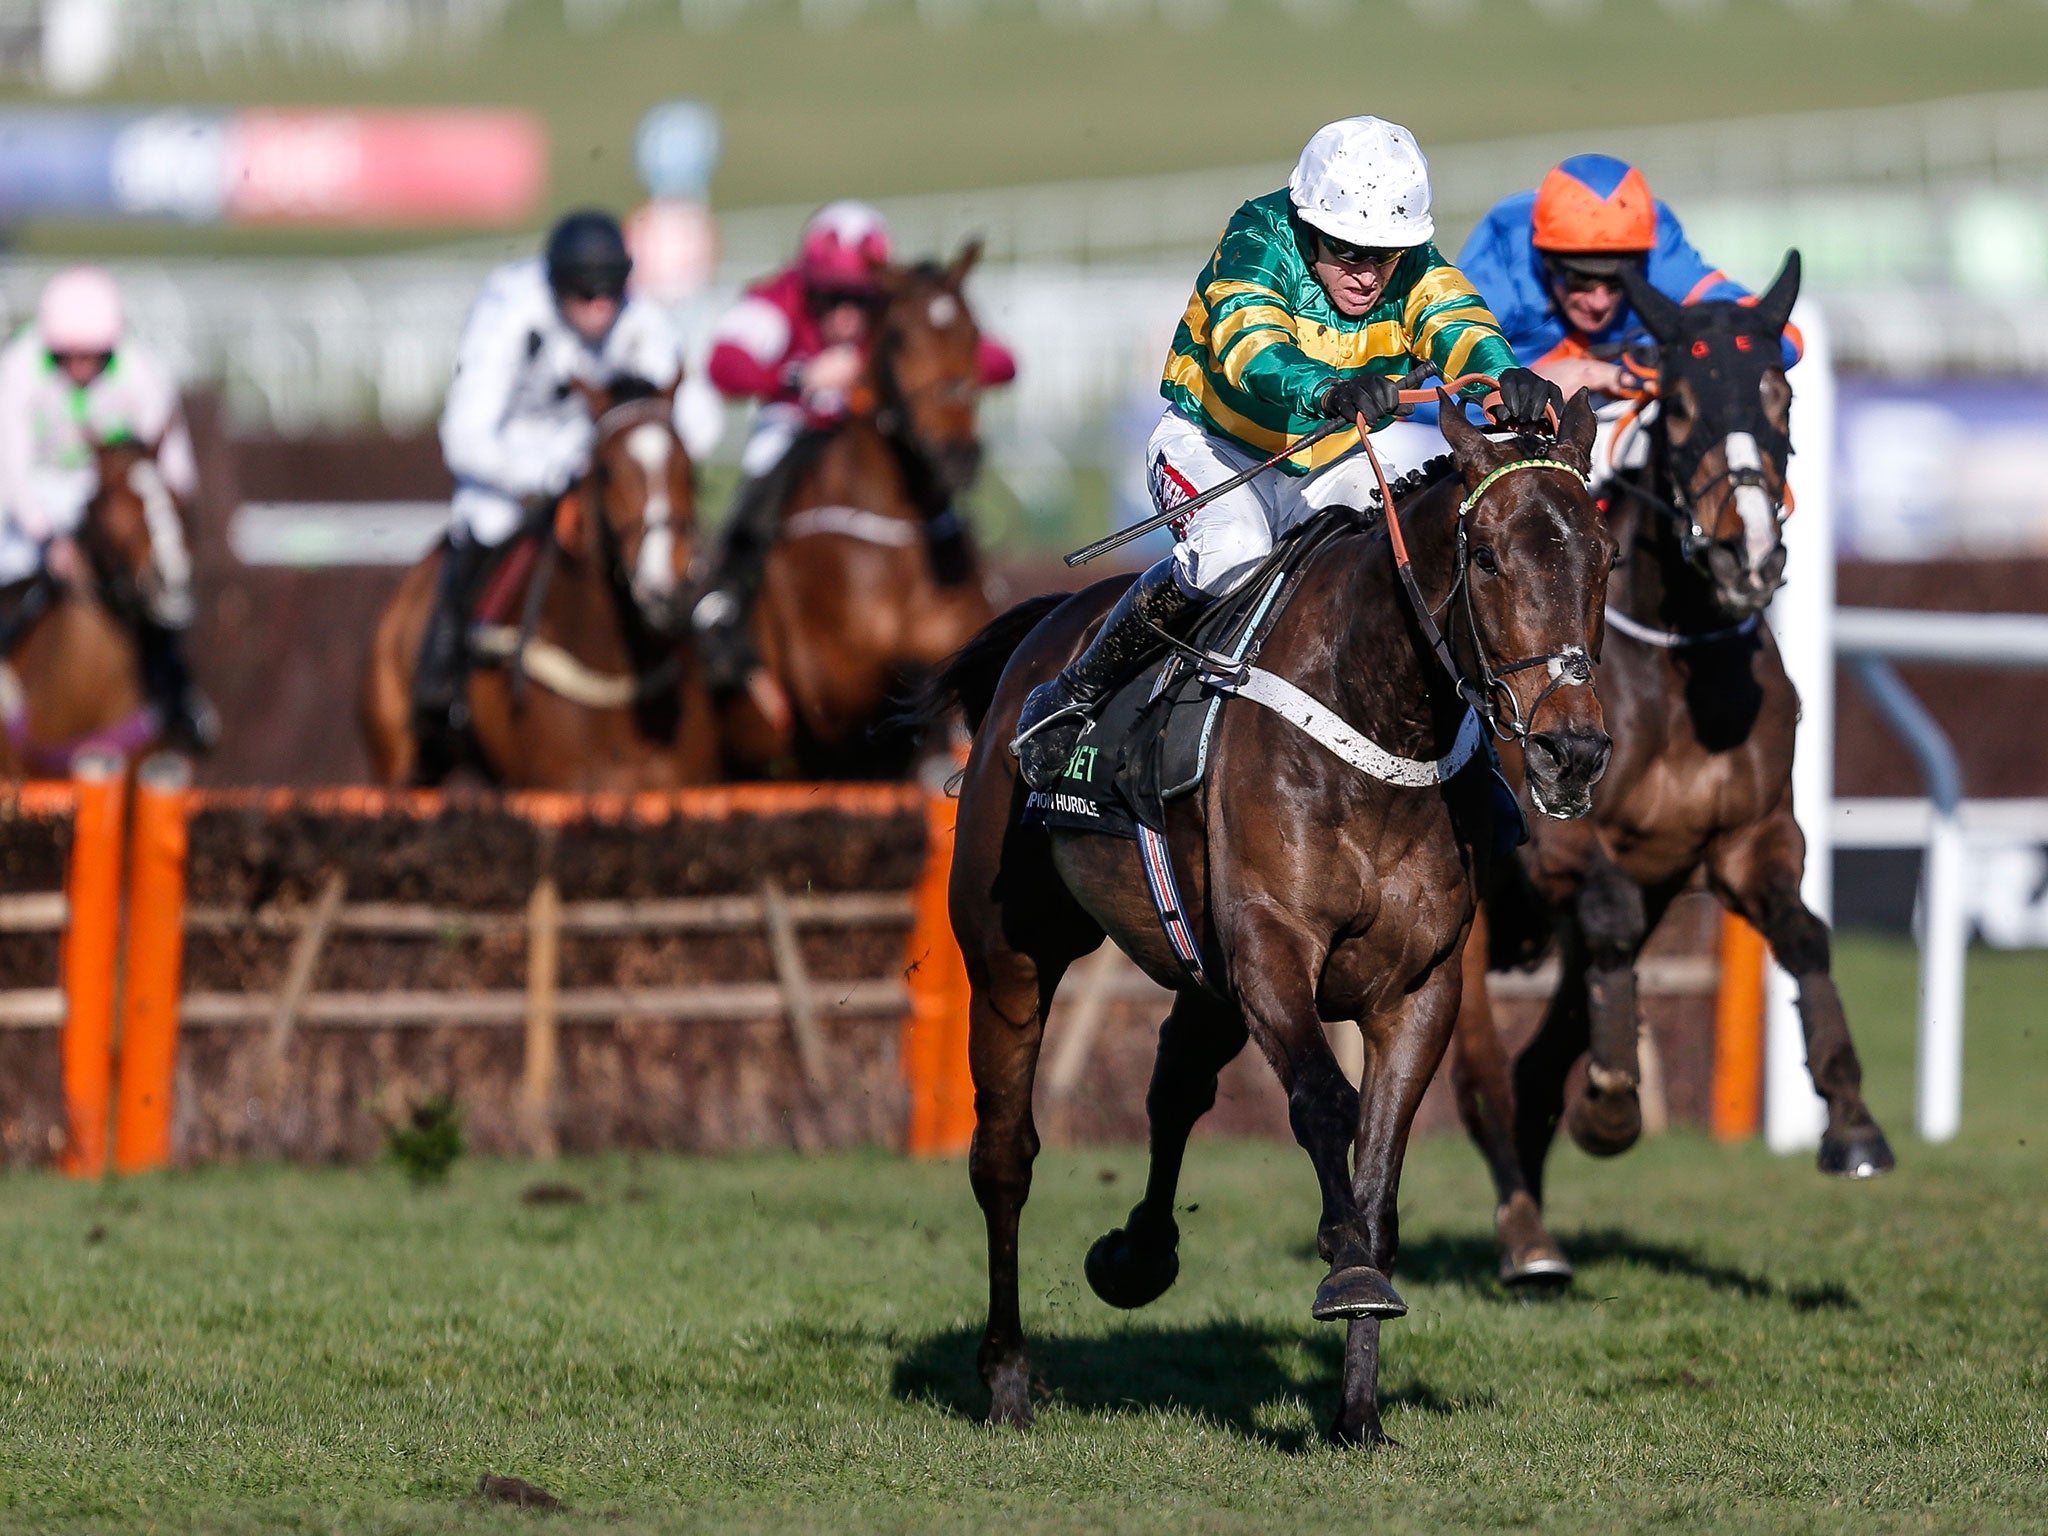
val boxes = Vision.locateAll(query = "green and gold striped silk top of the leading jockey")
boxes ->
[1159,188,1516,475]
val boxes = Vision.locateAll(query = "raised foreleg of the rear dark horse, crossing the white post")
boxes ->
[1706,791,1894,1178]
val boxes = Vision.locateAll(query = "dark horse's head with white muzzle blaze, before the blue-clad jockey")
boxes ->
[1622,250,1798,618]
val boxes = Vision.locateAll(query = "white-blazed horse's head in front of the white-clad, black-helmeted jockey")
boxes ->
[578,379,696,635]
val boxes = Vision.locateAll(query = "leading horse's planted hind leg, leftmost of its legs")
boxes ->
[967,950,1065,1430]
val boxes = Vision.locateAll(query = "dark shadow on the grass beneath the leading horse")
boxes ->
[893,1321,1491,1454]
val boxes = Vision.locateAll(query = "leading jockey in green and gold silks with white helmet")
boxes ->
[1012,117,1563,788]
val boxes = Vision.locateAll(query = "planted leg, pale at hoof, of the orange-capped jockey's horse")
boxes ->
[1450,907,1571,1286]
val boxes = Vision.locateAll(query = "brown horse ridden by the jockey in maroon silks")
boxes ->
[723,244,993,778]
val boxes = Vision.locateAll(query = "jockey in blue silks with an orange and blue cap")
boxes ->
[1458,156,1800,405]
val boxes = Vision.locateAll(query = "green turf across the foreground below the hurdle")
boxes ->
[0,940,2048,1536]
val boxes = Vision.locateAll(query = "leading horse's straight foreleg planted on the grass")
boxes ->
[1329,956,1460,1446]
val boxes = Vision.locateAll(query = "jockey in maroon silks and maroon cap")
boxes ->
[692,201,1018,688]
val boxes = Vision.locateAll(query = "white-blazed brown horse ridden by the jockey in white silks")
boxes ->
[362,381,719,791]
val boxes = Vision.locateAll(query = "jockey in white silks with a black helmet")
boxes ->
[425,209,682,752]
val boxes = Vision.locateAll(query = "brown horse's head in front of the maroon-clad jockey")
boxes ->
[870,240,981,498]
